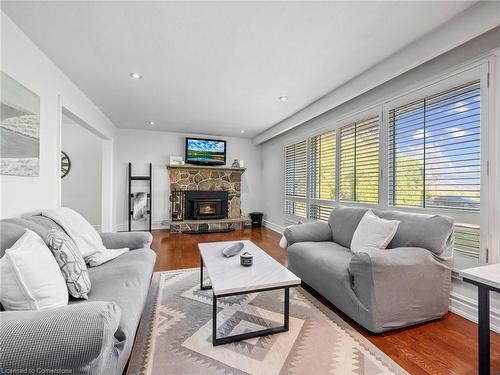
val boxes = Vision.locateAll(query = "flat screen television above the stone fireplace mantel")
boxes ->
[186,138,226,165]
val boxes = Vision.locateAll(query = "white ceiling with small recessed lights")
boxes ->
[1,1,473,137]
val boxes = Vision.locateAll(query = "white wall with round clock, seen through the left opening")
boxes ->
[61,116,102,229]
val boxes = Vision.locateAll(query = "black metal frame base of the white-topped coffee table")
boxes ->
[200,256,290,346]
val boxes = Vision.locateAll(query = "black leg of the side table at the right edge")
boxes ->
[478,286,490,375]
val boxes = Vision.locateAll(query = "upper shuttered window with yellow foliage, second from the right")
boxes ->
[340,116,380,203]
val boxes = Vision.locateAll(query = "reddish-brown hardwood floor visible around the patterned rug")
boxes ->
[152,228,500,375]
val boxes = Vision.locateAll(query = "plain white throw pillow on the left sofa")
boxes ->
[0,229,68,310]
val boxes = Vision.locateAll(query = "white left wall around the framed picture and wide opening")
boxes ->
[0,12,115,223]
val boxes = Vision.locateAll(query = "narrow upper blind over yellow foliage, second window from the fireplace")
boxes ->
[309,131,337,201]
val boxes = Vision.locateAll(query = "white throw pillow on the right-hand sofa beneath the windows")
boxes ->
[351,210,399,253]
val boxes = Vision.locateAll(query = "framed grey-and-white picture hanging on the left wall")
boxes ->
[0,72,40,177]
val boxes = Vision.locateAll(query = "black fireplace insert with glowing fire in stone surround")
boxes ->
[184,190,228,220]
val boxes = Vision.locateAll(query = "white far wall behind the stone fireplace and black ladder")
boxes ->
[114,129,263,230]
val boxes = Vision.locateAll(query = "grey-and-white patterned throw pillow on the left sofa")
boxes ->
[46,228,90,299]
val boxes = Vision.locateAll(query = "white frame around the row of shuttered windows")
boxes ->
[283,59,492,268]
